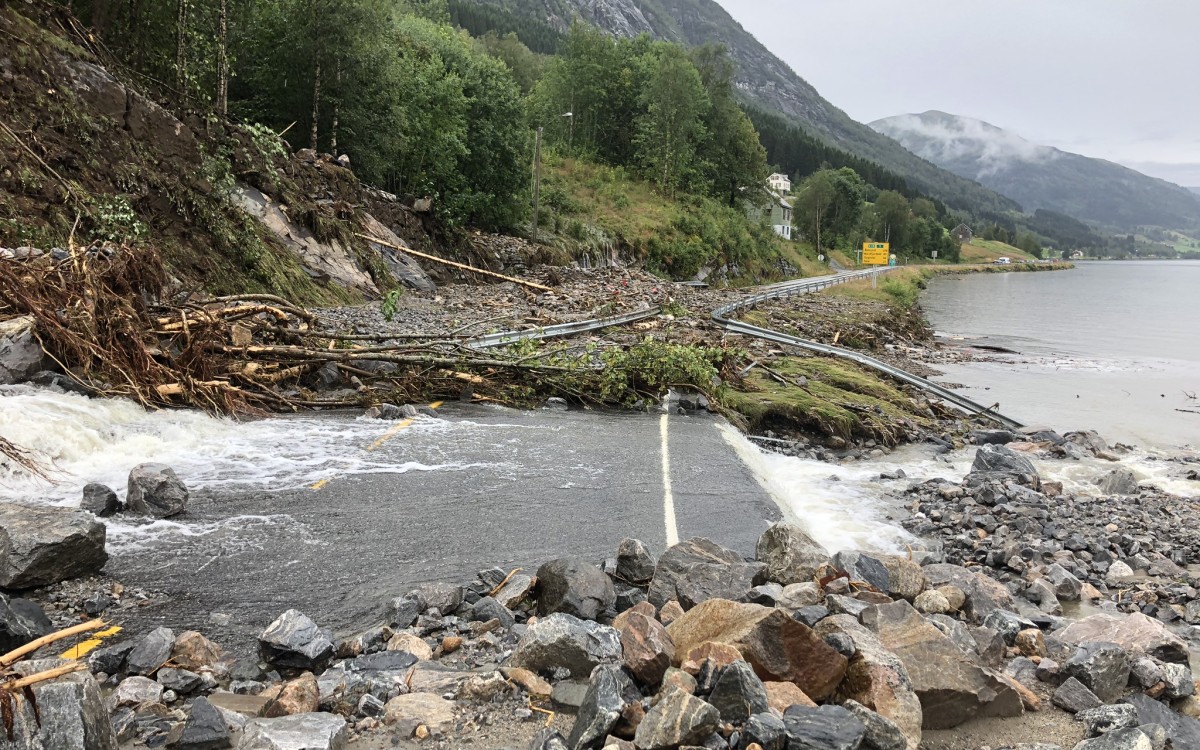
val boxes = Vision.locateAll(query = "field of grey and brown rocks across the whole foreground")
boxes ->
[0,432,1200,750]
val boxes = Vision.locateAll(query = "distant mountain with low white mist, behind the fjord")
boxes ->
[871,112,1200,229]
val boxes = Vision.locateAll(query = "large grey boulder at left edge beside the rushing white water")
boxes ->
[0,503,108,589]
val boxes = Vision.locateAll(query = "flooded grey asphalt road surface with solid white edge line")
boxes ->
[106,404,780,647]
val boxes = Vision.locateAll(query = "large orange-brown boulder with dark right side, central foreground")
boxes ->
[667,599,846,701]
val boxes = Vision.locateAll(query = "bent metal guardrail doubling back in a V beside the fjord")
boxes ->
[713,269,1022,430]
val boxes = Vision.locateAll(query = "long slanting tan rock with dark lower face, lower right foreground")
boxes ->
[862,600,1024,730]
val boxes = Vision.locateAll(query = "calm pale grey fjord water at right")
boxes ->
[922,260,1200,450]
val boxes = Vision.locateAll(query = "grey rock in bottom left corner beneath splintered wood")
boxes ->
[0,659,118,750]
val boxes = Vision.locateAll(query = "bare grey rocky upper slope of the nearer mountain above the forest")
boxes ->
[455,0,1019,212]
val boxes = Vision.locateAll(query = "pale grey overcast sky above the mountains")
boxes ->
[718,0,1200,186]
